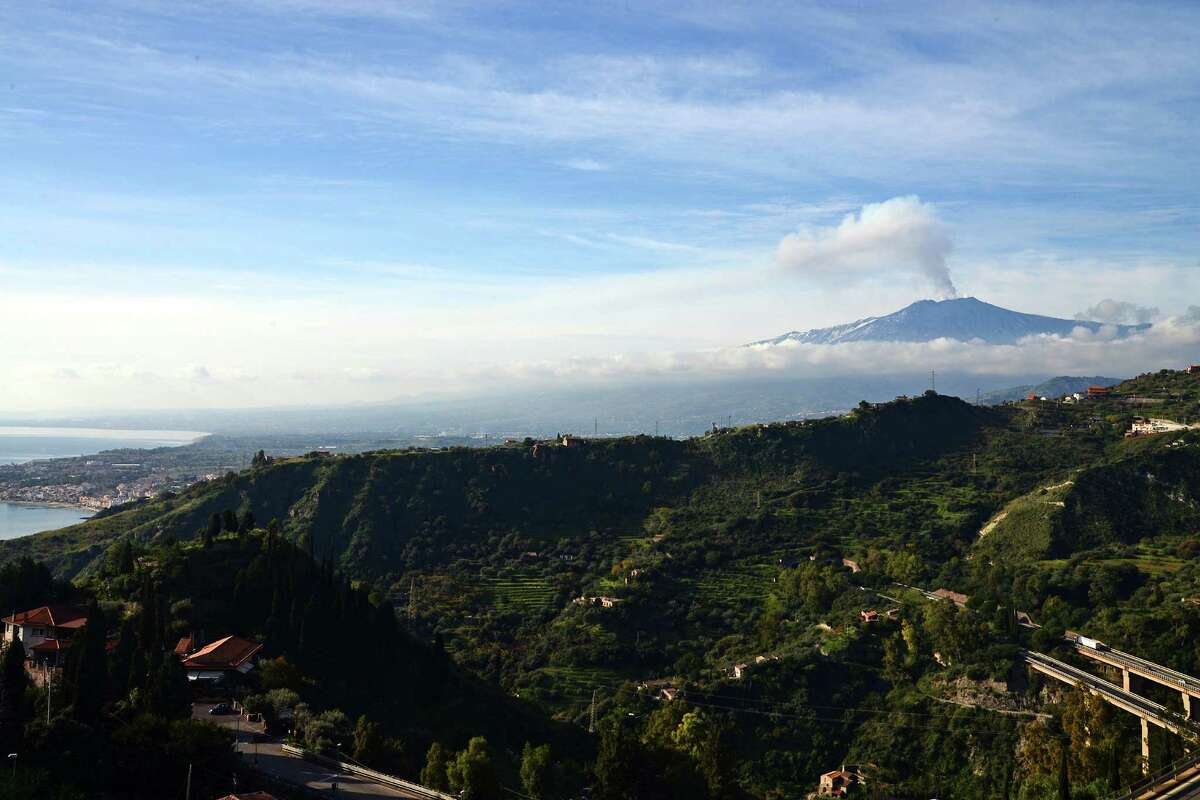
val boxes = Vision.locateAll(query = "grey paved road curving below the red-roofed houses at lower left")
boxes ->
[192,703,436,800]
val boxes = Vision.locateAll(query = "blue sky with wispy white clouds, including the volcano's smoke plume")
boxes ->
[0,0,1200,411]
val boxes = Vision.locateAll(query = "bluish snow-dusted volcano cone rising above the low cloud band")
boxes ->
[748,297,1150,347]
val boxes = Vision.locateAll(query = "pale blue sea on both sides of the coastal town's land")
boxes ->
[0,426,204,539]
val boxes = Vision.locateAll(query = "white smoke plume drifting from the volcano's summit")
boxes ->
[776,194,958,299]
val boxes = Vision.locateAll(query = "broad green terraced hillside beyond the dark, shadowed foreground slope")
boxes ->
[7,373,1200,798]
